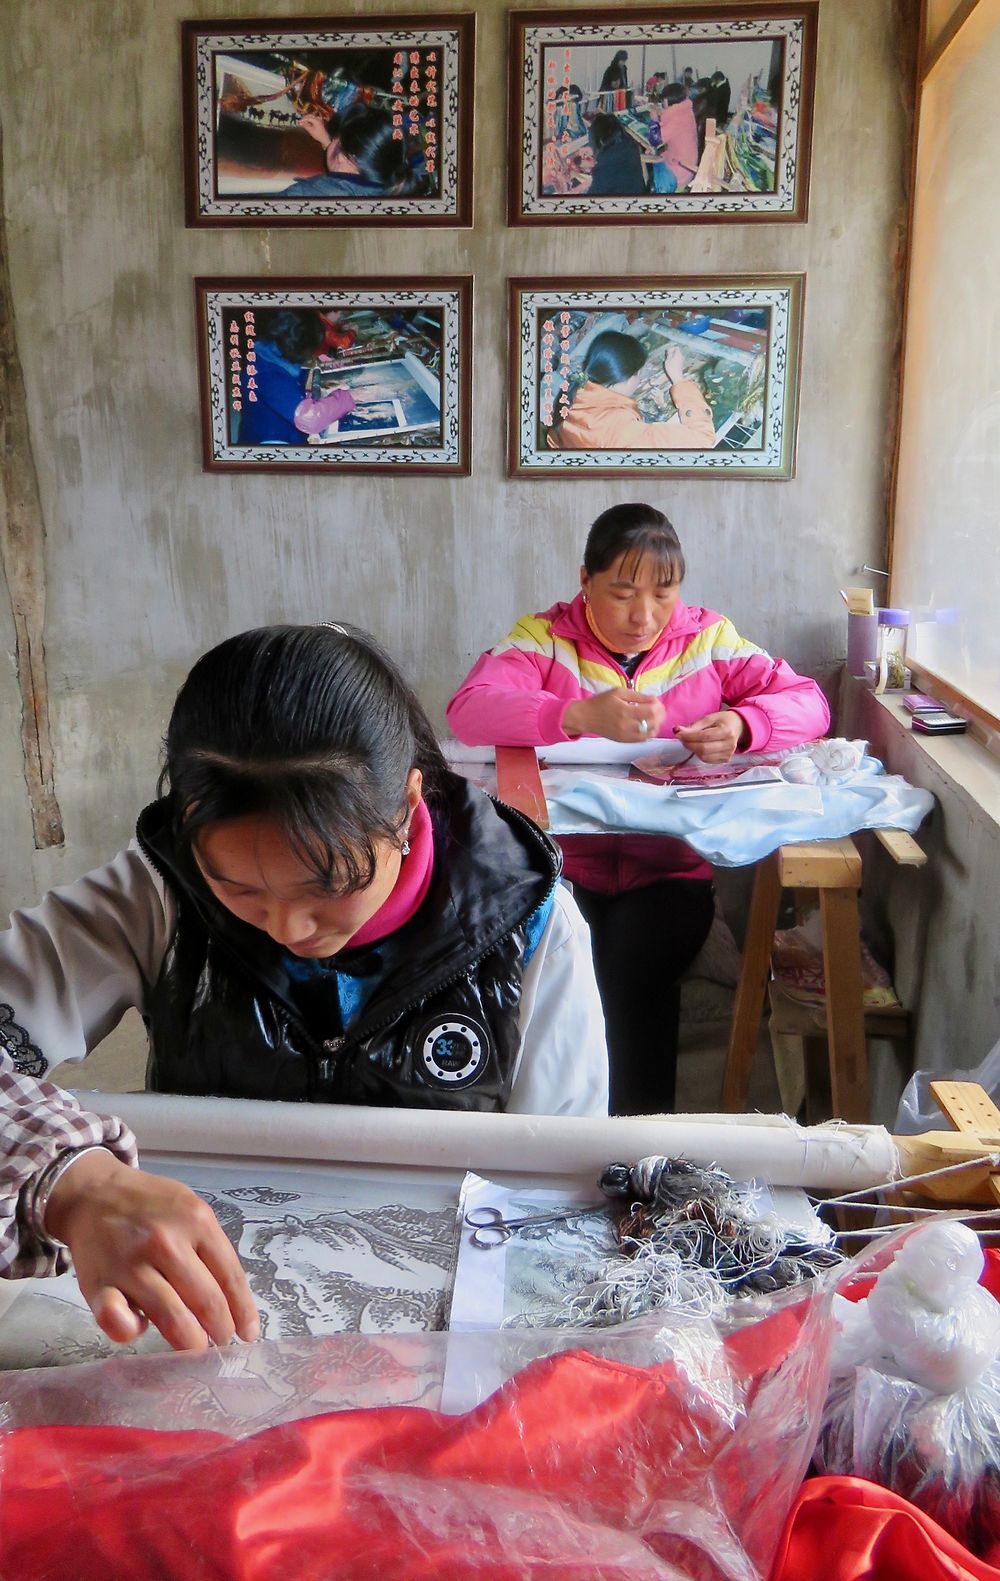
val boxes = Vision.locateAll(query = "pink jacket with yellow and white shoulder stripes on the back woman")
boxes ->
[447,593,829,893]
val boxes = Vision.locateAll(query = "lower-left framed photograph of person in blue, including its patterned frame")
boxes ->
[194,277,472,474]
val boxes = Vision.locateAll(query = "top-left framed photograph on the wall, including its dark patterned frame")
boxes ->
[182,14,476,228]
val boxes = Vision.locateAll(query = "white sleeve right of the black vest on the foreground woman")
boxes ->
[507,884,608,1115]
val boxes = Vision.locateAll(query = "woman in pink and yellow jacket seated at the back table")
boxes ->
[447,504,829,1115]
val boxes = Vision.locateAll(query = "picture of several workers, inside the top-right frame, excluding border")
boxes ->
[540,38,784,198]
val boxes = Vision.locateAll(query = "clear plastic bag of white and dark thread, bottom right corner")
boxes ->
[814,1221,1000,1564]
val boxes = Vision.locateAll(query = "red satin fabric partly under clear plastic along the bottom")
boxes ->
[0,1254,1000,1581]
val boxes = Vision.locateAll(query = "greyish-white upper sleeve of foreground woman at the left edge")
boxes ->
[0,843,175,1077]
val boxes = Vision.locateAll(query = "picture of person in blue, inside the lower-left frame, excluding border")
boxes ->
[221,304,442,449]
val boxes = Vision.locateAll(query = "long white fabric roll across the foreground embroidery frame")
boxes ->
[70,1092,900,1190]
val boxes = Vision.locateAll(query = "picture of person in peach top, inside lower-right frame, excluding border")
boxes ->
[537,302,771,452]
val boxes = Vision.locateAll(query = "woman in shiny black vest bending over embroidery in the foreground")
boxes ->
[0,626,608,1347]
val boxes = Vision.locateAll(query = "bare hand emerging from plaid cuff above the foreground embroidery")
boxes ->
[46,1148,261,1350]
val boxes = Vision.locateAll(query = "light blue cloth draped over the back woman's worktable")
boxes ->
[542,756,934,868]
